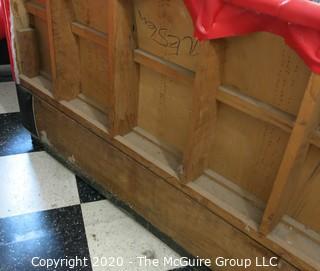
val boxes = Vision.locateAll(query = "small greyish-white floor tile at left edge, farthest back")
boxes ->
[0,82,20,114]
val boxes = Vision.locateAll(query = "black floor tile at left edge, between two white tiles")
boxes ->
[0,113,42,156]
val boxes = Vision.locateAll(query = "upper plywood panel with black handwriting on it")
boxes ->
[134,0,199,70]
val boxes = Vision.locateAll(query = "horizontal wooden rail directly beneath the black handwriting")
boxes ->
[134,49,195,84]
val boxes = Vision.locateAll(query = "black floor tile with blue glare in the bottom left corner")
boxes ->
[0,205,92,271]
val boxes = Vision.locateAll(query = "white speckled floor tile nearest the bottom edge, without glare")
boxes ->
[81,200,179,271]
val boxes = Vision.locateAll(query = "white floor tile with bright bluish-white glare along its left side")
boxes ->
[0,152,80,218]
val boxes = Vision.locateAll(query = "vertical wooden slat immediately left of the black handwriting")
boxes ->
[107,0,138,136]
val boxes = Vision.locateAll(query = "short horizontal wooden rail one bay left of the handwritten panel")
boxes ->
[71,22,108,47]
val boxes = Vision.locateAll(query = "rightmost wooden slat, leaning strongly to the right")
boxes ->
[260,74,320,235]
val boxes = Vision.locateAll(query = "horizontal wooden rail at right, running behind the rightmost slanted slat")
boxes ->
[217,86,320,148]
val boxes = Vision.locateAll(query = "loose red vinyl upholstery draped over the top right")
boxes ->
[185,0,320,73]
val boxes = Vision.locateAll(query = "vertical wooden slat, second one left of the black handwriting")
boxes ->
[46,0,80,100]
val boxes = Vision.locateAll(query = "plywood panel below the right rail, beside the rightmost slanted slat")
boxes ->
[209,103,288,201]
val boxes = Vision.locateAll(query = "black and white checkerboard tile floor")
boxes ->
[0,78,195,271]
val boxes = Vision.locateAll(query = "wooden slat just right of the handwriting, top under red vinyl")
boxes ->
[181,41,223,183]
